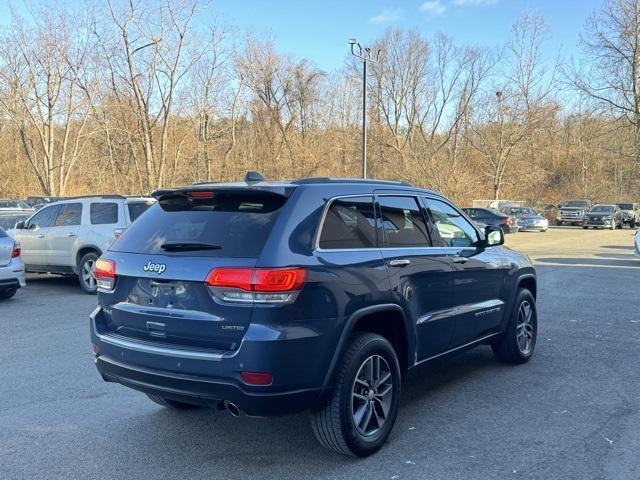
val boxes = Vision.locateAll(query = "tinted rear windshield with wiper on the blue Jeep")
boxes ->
[111,192,287,258]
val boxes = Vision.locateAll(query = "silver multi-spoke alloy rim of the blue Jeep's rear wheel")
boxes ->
[351,355,393,437]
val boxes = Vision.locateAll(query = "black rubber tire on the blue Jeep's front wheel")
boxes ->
[491,288,538,364]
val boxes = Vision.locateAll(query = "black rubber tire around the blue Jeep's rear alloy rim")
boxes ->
[311,333,401,457]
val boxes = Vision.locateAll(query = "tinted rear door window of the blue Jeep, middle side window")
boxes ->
[378,197,431,248]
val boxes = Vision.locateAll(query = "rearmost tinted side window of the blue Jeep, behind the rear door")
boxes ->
[319,197,376,249]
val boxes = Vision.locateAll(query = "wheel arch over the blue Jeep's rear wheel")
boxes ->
[324,303,415,386]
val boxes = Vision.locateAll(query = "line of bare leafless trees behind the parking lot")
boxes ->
[0,0,640,203]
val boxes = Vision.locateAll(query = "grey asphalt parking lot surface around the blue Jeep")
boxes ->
[0,228,640,480]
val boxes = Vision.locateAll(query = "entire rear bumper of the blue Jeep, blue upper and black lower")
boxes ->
[91,307,337,416]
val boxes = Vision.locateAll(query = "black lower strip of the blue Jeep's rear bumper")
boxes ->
[95,355,323,416]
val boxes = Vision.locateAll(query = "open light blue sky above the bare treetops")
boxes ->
[0,0,602,70]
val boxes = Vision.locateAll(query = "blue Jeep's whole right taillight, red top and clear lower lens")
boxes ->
[206,267,307,303]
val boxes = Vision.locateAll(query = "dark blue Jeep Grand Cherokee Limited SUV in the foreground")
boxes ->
[91,175,537,456]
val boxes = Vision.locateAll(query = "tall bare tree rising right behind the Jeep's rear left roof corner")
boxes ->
[100,0,202,189]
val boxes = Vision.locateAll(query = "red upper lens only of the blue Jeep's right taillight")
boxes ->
[207,268,307,292]
